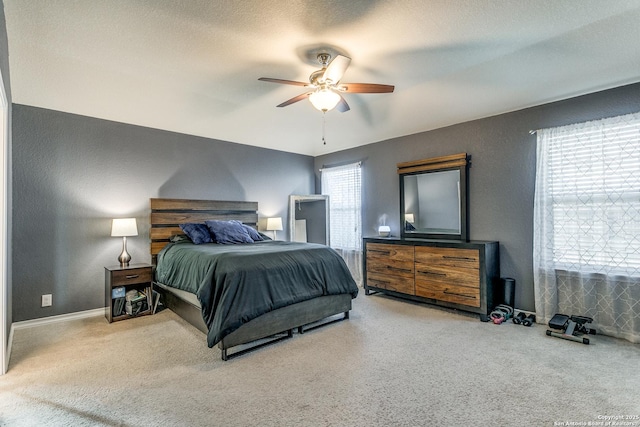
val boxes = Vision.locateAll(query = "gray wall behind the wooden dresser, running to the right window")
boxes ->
[314,84,640,314]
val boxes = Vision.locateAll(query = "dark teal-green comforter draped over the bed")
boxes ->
[156,241,358,347]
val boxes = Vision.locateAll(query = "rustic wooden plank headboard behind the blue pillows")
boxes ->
[149,199,258,265]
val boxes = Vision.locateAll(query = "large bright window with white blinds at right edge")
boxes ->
[536,114,640,275]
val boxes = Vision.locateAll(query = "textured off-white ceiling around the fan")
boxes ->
[4,0,640,156]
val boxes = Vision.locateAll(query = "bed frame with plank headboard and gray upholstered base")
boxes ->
[149,199,351,360]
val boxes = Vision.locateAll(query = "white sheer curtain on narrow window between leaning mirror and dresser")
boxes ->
[321,163,362,285]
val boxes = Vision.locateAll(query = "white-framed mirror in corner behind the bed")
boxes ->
[289,194,329,245]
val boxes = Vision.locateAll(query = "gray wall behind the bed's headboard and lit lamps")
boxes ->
[12,106,315,322]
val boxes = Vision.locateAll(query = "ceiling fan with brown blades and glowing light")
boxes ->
[258,53,394,113]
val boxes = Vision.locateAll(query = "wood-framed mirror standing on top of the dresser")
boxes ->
[398,153,468,240]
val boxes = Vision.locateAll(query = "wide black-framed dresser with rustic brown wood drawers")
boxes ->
[363,237,502,314]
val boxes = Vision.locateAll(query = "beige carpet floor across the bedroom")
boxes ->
[0,292,640,426]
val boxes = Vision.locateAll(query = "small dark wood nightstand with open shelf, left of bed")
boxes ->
[104,264,153,323]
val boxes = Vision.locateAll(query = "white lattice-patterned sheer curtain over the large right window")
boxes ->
[533,113,640,343]
